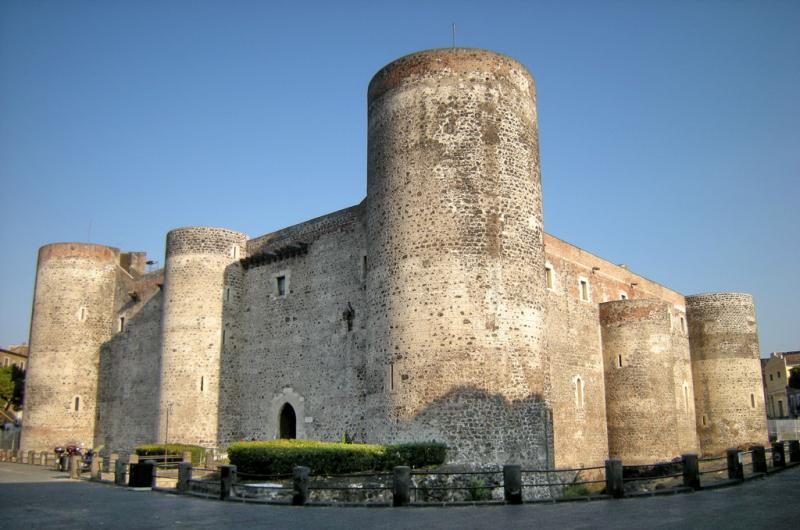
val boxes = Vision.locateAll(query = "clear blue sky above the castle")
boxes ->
[0,0,800,353]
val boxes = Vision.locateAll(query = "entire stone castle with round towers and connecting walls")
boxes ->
[22,48,767,467]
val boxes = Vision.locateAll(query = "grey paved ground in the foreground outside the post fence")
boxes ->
[0,462,800,530]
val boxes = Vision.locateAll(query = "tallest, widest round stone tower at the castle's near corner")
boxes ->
[367,48,549,462]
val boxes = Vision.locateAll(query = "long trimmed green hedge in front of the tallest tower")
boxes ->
[228,440,447,475]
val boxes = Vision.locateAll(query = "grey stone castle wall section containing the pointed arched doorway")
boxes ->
[231,207,369,441]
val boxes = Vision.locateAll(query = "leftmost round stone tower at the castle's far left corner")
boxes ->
[21,243,119,451]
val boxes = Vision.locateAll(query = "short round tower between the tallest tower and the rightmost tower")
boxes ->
[600,299,698,464]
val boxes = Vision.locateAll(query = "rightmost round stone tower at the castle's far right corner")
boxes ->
[686,293,767,454]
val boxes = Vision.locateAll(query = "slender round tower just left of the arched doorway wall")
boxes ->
[158,227,247,447]
